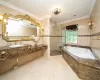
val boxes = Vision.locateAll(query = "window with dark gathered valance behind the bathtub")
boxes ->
[62,25,78,44]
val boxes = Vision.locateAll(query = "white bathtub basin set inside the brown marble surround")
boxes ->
[64,46,96,59]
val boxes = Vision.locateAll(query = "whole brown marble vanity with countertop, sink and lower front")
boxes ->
[0,45,47,74]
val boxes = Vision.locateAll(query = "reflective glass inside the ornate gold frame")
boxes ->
[6,18,37,36]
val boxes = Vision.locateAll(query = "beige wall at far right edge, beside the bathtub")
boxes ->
[91,0,100,58]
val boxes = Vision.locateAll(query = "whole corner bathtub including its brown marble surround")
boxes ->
[62,46,100,80]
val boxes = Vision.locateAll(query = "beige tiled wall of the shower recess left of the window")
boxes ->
[50,24,62,52]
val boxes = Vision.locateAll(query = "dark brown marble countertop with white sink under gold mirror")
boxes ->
[0,44,47,59]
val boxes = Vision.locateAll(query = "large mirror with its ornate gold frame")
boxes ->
[2,14,42,42]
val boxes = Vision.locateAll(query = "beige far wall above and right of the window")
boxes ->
[61,18,90,46]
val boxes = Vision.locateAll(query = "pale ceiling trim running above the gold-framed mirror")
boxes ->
[0,0,41,20]
